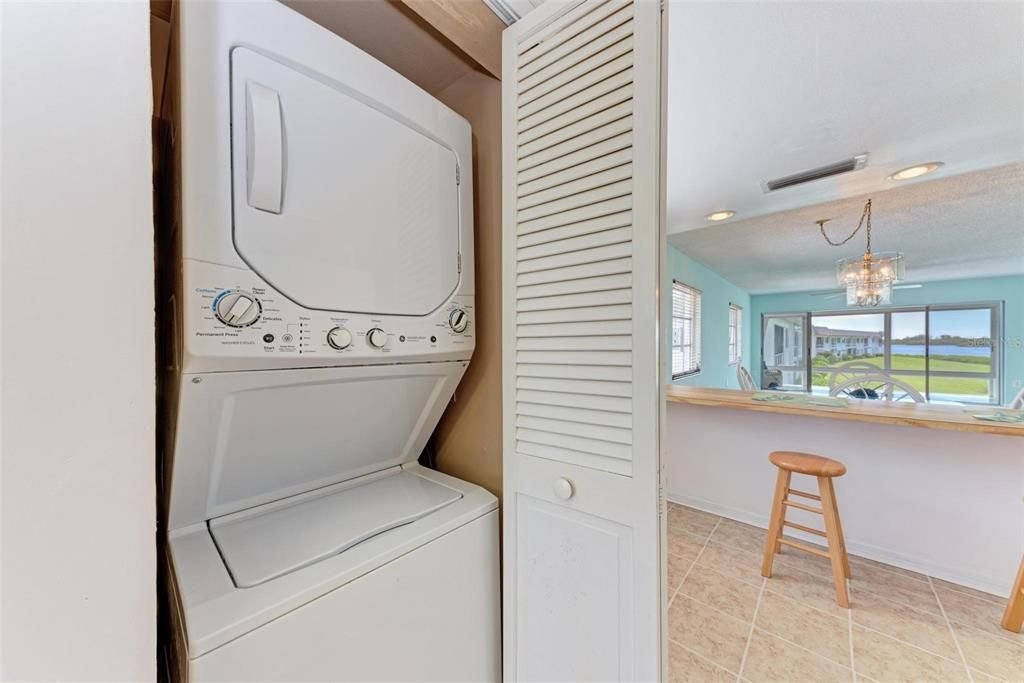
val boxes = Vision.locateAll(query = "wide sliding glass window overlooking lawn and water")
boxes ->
[762,304,1000,403]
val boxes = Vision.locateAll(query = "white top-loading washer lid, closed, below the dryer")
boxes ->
[210,470,462,588]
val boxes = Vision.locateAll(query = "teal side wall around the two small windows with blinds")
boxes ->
[666,246,761,389]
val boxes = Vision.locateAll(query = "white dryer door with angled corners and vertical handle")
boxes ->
[232,47,460,315]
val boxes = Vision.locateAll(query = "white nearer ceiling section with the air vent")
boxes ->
[668,1,1024,232]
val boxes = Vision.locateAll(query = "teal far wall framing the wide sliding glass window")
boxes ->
[745,276,1024,402]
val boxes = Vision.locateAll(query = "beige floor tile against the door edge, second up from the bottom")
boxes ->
[669,596,751,671]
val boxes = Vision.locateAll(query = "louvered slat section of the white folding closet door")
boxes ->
[512,6,634,474]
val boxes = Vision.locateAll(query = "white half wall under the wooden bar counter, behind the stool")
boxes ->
[666,403,1024,597]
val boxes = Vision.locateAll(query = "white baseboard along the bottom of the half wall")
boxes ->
[666,492,1009,598]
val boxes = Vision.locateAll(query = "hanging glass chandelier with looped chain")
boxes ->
[815,200,903,306]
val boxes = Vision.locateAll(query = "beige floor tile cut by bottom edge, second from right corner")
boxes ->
[853,626,968,683]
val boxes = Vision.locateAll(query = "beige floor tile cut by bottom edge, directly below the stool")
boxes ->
[741,629,853,683]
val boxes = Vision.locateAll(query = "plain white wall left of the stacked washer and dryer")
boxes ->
[0,2,157,681]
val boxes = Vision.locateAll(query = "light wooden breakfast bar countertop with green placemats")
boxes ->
[666,385,1024,438]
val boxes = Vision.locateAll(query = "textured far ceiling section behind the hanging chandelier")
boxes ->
[669,164,1024,294]
